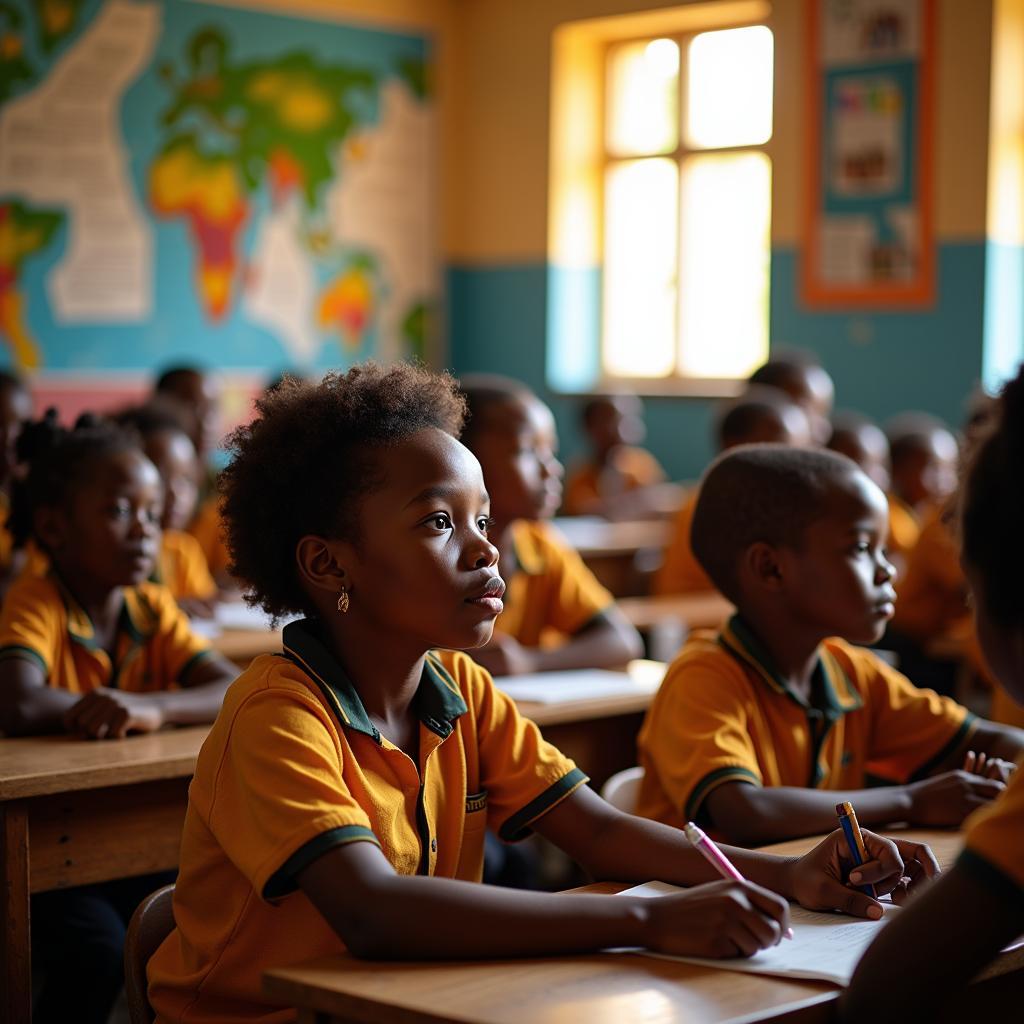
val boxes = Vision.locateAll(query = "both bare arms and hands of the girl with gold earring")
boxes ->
[297,787,927,958]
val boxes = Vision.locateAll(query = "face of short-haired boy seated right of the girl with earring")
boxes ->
[779,470,896,644]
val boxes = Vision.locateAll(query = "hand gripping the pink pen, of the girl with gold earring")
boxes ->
[638,882,790,957]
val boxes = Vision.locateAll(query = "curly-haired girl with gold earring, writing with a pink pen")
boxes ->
[148,365,934,1024]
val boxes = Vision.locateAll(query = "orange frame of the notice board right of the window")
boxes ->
[801,0,935,309]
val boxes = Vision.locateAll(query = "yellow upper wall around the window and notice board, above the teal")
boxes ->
[445,0,992,265]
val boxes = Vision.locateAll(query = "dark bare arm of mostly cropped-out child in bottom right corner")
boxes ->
[840,865,1024,1024]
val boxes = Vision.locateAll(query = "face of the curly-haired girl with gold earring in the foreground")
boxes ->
[348,428,505,650]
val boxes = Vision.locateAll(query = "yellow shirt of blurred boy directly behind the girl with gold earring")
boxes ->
[495,519,614,647]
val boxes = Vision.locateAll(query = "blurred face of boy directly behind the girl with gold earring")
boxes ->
[474,395,563,526]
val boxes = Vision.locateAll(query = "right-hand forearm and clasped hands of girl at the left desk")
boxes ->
[65,651,239,739]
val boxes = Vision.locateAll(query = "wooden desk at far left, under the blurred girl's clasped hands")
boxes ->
[0,726,207,1024]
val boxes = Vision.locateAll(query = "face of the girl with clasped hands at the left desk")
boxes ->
[47,451,164,593]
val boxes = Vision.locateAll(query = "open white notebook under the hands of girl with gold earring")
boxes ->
[620,882,1024,985]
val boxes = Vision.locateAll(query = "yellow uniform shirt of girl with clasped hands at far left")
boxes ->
[0,571,210,693]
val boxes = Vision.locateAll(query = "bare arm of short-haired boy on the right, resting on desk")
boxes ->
[705,771,1006,846]
